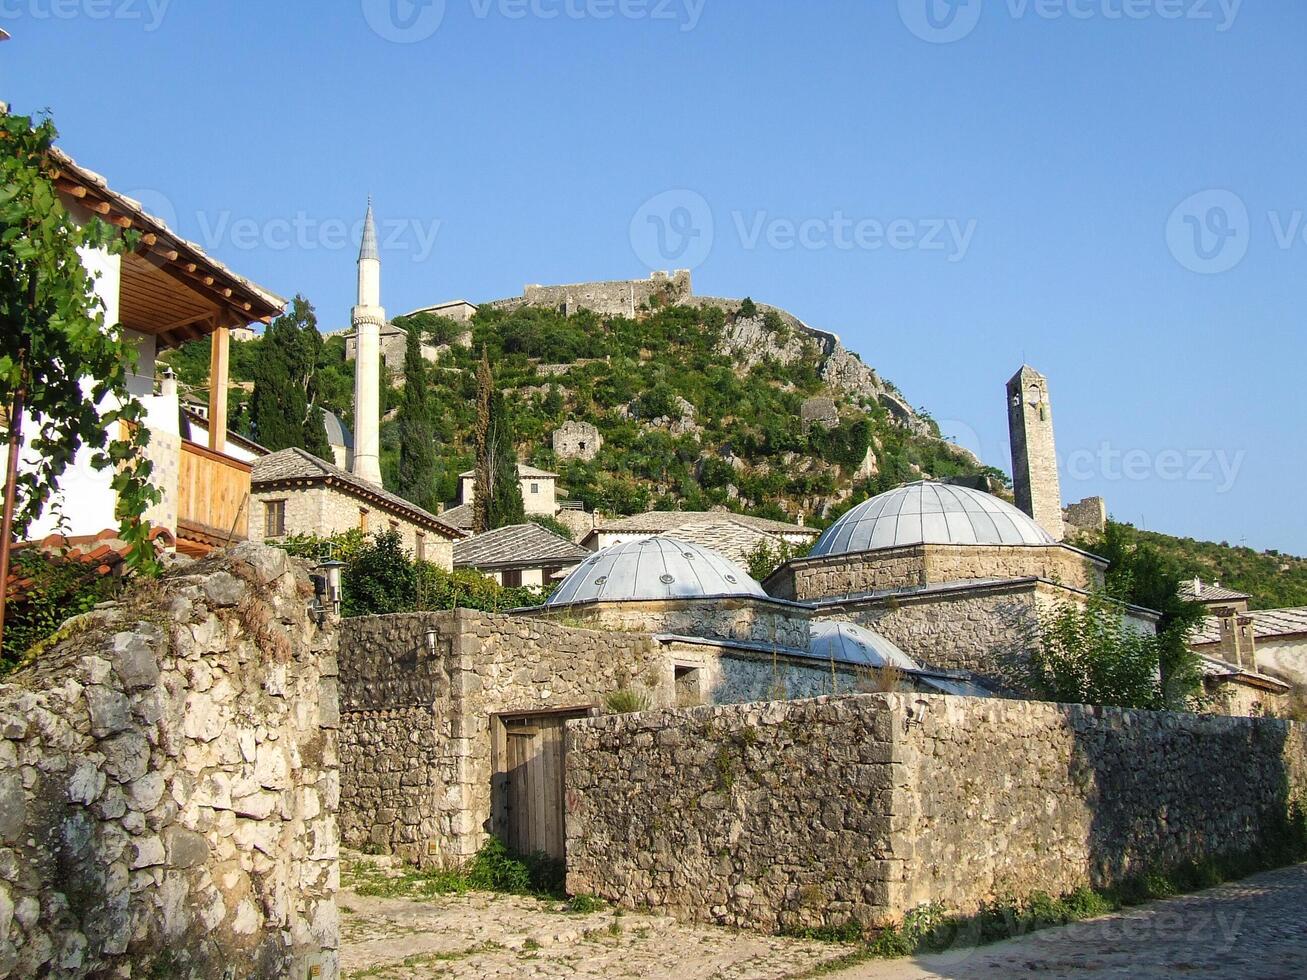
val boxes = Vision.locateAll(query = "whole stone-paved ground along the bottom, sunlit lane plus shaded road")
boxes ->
[340,865,1307,980]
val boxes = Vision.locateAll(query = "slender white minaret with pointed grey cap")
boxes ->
[352,199,386,486]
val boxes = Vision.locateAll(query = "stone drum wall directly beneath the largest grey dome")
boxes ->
[766,545,1106,601]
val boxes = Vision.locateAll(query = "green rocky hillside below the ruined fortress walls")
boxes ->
[383,290,1004,523]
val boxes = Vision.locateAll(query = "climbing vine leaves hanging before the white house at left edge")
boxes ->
[0,115,159,571]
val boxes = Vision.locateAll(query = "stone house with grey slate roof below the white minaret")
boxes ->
[250,448,467,571]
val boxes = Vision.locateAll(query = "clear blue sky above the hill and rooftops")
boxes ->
[0,0,1307,554]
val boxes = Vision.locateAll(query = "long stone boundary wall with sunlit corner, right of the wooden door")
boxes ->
[566,694,1307,930]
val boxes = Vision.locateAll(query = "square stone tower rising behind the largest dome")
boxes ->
[1008,366,1067,541]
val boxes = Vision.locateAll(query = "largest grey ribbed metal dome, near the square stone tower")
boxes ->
[812,482,1057,558]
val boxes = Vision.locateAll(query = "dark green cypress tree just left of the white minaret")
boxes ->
[250,295,331,457]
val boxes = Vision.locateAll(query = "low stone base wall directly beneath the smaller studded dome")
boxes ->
[520,598,812,649]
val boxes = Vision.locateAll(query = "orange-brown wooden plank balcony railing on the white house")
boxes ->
[176,439,251,554]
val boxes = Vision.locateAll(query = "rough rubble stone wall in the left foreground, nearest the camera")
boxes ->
[0,545,339,977]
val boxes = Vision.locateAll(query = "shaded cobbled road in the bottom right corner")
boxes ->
[833,865,1307,980]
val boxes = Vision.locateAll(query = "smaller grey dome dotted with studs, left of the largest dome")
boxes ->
[546,537,767,606]
